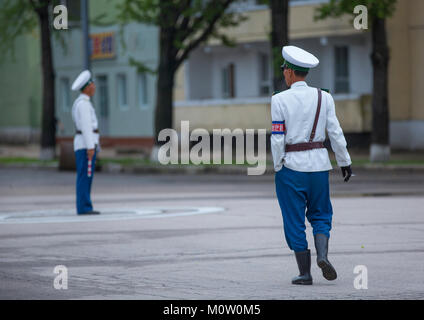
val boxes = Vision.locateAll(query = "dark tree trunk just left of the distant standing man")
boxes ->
[36,2,56,160]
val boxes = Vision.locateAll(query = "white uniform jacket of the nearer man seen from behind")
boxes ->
[271,81,352,172]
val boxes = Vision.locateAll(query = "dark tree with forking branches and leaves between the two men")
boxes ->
[118,0,245,142]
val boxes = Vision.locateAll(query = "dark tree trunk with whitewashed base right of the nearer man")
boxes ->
[370,18,390,162]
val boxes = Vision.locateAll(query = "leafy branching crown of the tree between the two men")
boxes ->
[118,0,244,68]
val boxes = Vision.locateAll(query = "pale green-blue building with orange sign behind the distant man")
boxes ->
[54,0,158,147]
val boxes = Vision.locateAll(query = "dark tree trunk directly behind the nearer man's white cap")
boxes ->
[270,0,289,91]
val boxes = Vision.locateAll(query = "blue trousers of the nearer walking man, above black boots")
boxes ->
[275,167,333,252]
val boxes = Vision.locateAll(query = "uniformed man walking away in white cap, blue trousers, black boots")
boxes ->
[271,46,352,285]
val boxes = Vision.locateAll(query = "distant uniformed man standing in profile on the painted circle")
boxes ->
[72,70,100,215]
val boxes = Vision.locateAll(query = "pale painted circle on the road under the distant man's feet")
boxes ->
[0,207,225,224]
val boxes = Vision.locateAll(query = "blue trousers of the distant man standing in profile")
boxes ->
[75,149,97,214]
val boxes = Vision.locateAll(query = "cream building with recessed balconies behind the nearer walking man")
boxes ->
[174,0,424,149]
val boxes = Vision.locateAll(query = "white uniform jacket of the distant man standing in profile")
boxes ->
[72,93,99,151]
